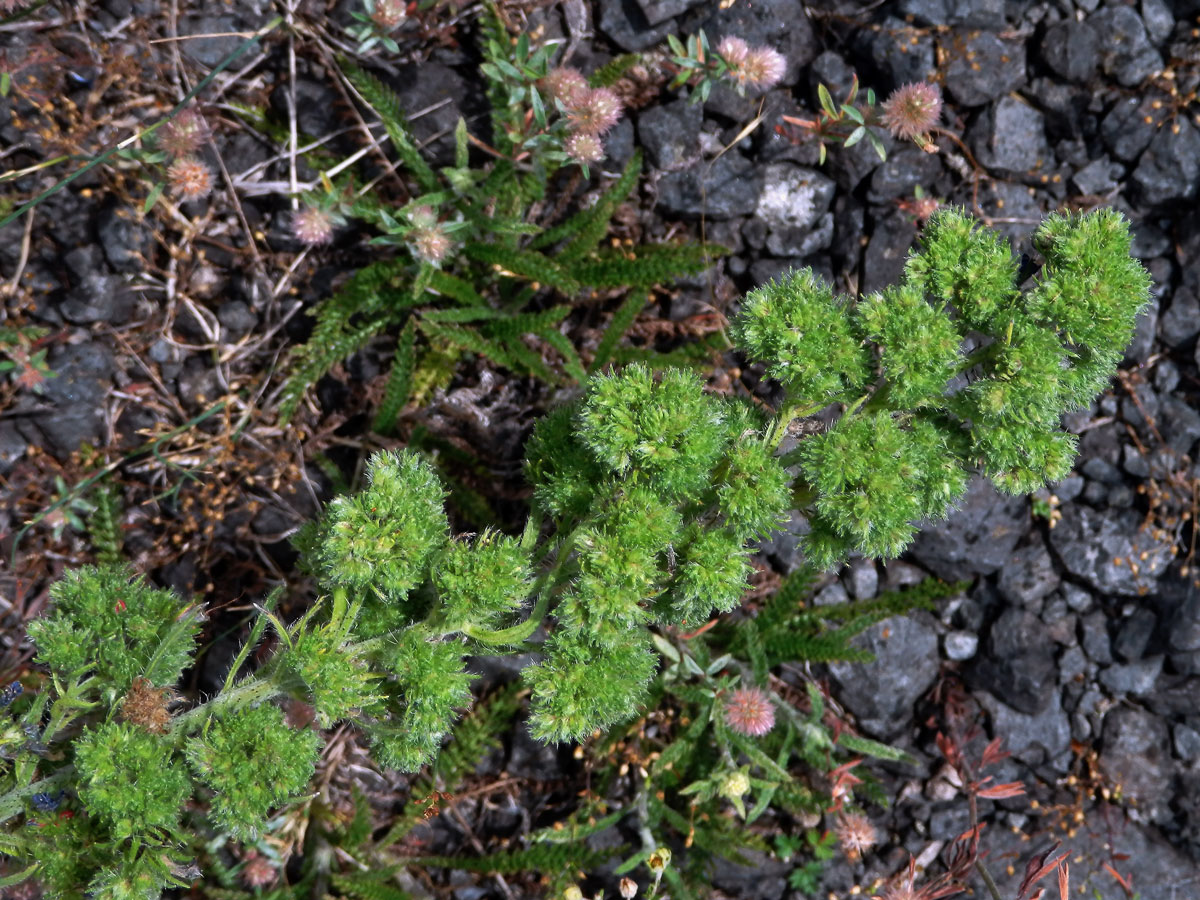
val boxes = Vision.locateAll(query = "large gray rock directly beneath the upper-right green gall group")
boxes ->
[911,475,1027,581]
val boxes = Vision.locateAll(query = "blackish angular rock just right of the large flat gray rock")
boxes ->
[967,610,1058,715]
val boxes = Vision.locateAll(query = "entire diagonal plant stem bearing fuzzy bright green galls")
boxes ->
[0,211,1148,896]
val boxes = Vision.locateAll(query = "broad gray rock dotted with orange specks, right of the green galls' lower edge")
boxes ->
[1050,505,1172,595]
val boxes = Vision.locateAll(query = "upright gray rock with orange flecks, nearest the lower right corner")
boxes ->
[1099,707,1174,822]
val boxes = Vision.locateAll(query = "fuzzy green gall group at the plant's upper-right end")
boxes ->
[733,210,1150,565]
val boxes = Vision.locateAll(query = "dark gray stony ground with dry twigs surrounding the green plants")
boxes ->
[0,0,1200,900]
